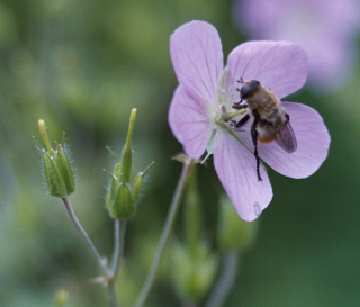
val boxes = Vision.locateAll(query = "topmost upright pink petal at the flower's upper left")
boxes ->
[170,21,224,103]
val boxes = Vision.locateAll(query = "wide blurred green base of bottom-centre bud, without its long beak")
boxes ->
[172,243,217,303]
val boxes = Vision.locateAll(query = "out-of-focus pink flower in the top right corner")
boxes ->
[233,0,360,88]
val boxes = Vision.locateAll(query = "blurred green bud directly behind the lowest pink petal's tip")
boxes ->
[218,197,258,252]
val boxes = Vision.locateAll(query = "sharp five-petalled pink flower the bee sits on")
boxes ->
[169,21,330,221]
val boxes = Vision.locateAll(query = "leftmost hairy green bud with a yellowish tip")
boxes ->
[38,119,75,198]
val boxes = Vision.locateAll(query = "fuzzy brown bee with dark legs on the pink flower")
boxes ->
[232,80,297,181]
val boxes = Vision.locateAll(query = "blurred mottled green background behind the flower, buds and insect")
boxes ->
[0,0,360,307]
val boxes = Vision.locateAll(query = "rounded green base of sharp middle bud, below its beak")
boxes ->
[107,182,136,220]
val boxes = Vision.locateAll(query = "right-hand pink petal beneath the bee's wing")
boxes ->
[259,102,330,179]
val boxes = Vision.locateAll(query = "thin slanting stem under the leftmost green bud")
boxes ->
[62,198,109,276]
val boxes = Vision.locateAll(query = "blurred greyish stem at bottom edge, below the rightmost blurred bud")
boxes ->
[206,251,238,307]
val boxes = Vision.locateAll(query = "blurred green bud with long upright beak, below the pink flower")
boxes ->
[171,163,217,306]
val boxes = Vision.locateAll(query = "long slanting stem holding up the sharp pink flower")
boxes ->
[134,159,191,307]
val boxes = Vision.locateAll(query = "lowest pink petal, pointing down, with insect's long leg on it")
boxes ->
[214,135,272,222]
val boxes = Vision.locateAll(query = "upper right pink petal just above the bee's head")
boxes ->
[228,41,308,98]
